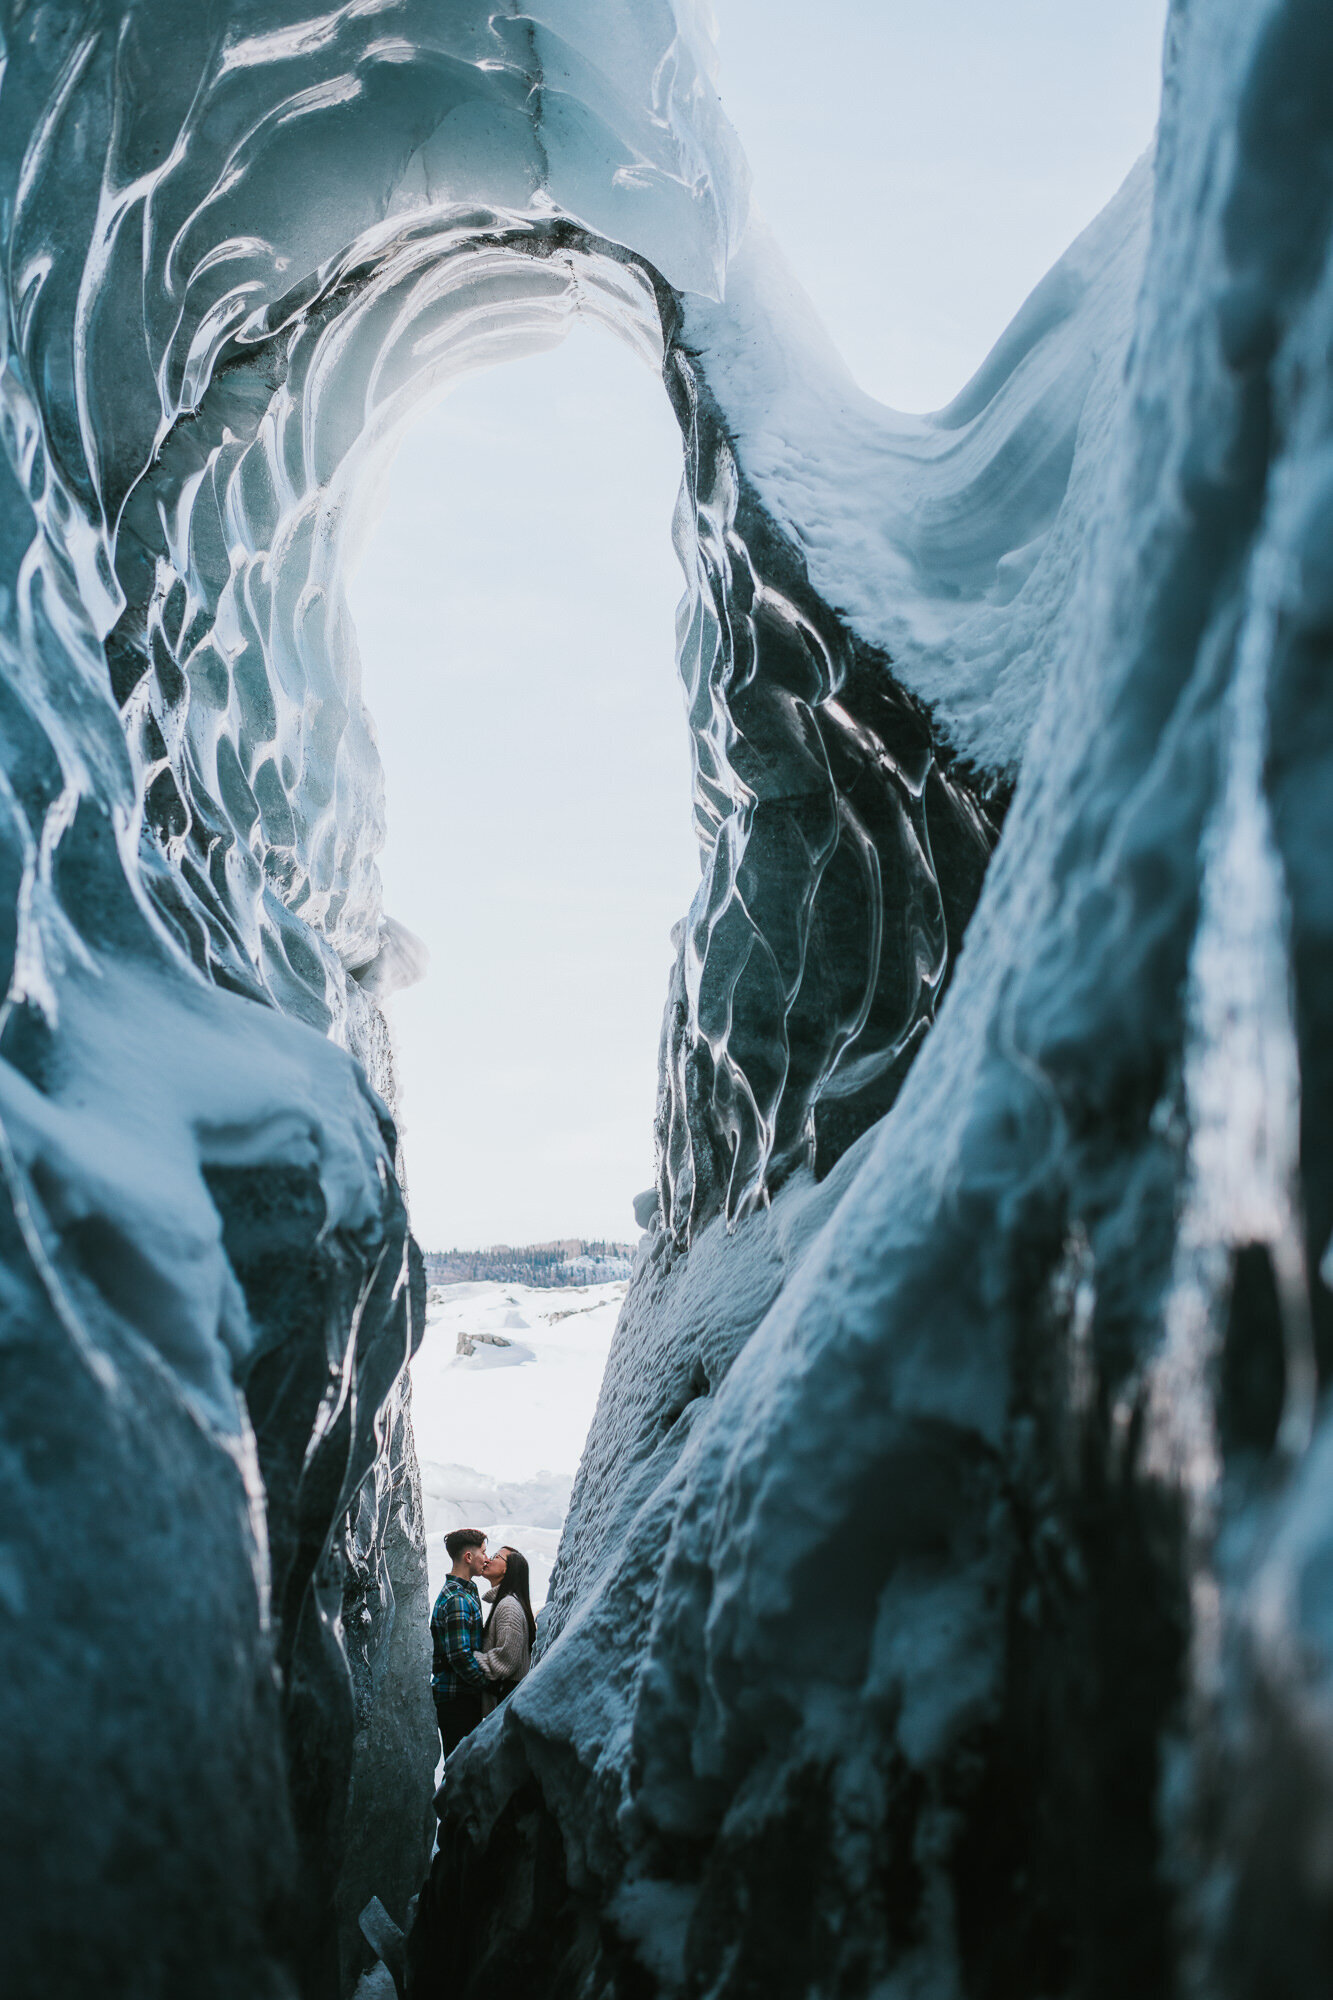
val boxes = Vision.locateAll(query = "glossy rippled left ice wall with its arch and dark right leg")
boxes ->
[0,11,1008,1996]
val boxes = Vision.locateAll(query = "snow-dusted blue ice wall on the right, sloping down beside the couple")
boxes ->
[416,11,1333,2000]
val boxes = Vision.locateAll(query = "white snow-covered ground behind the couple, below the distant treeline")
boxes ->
[412,1280,626,1610]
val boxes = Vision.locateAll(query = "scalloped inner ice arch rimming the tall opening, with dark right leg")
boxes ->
[106,195,1008,1244]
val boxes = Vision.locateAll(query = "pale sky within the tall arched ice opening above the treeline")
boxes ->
[348,322,699,1250]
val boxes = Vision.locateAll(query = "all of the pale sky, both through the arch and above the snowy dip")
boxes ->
[350,0,1165,1248]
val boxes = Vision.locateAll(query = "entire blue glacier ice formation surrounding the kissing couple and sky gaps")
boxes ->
[0,0,1333,2000]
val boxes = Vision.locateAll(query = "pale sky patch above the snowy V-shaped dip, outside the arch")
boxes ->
[713,0,1167,410]
